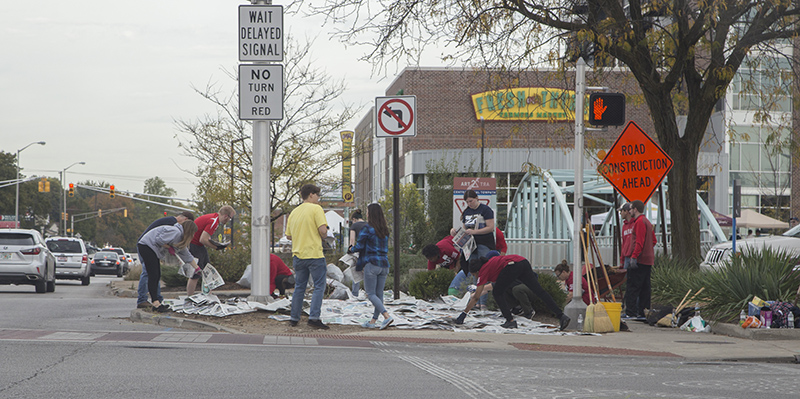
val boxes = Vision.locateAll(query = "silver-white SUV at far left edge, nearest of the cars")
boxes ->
[0,229,56,294]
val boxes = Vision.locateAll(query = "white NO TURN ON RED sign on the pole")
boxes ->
[239,64,283,121]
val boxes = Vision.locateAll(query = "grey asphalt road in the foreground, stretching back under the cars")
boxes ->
[0,277,800,399]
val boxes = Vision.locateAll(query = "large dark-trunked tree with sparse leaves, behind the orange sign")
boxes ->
[315,0,800,259]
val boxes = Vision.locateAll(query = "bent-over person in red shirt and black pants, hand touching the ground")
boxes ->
[456,255,570,330]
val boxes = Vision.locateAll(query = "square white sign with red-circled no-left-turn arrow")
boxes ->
[375,96,417,137]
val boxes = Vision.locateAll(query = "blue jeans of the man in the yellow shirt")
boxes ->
[290,256,328,321]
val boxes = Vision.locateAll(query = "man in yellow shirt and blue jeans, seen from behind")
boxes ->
[286,184,328,330]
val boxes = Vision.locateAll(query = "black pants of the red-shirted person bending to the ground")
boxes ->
[494,260,564,320]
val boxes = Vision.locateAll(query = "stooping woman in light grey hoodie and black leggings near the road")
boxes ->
[137,220,200,313]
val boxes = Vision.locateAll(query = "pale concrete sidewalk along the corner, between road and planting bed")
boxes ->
[110,281,800,363]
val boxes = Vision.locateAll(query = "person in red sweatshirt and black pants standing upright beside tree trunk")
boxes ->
[625,200,656,318]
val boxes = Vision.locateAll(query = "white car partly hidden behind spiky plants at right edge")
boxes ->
[700,225,800,270]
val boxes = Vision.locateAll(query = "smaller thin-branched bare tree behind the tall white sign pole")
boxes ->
[176,37,357,219]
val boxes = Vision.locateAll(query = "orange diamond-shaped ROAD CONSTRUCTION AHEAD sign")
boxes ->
[597,121,673,202]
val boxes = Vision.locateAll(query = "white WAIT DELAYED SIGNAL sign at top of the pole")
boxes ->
[239,5,283,62]
